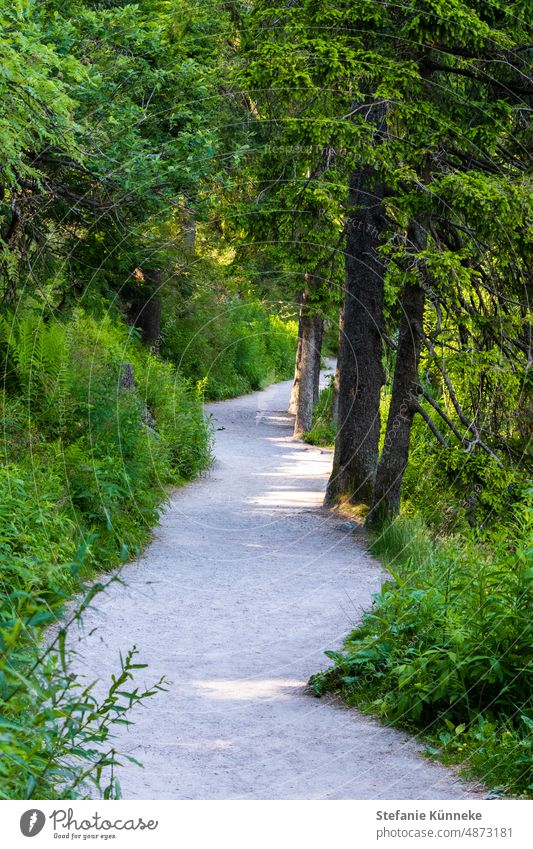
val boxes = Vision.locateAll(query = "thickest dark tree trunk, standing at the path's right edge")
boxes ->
[324,168,385,507]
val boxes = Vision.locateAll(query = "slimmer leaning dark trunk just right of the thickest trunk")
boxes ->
[367,219,425,526]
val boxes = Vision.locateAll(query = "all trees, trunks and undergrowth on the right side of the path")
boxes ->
[241,0,533,796]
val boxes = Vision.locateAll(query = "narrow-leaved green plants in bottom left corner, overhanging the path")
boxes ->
[0,561,165,799]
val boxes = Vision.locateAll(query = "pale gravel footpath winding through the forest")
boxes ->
[71,372,473,799]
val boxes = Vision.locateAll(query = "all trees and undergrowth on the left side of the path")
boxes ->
[0,0,295,799]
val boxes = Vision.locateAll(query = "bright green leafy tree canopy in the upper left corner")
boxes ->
[0,0,237,305]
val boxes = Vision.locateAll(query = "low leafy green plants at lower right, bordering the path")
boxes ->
[312,506,533,795]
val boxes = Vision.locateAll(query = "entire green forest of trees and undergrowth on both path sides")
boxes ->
[0,0,533,798]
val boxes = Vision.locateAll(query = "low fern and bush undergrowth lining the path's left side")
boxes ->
[0,297,294,799]
